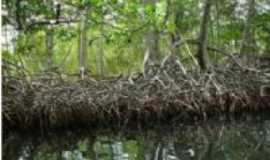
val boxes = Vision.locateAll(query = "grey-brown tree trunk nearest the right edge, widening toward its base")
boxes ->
[240,0,255,63]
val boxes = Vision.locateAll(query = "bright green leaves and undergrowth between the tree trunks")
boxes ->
[3,0,270,75]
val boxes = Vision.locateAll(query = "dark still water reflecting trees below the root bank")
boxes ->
[2,120,270,160]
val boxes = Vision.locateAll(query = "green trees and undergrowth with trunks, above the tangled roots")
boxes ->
[2,0,270,76]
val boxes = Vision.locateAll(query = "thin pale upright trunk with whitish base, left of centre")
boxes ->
[79,10,87,79]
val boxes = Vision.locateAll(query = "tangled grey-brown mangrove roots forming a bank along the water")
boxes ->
[3,57,270,129]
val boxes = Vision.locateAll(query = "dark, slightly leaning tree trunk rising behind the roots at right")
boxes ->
[197,0,212,70]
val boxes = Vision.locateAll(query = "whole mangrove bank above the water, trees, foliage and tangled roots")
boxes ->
[3,0,270,129]
